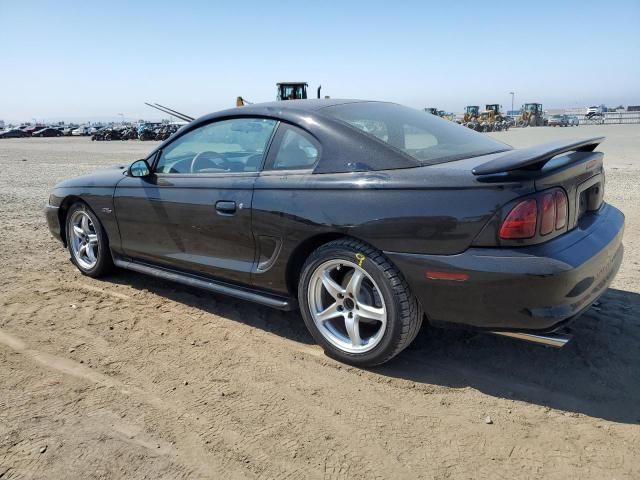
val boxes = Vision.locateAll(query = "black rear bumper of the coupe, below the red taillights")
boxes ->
[386,204,624,332]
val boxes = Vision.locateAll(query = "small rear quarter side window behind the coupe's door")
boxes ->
[271,124,320,170]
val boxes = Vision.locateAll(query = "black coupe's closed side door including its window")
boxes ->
[114,117,277,283]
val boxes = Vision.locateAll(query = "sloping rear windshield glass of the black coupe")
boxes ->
[323,102,511,165]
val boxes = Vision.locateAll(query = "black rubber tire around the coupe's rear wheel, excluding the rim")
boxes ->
[298,238,423,367]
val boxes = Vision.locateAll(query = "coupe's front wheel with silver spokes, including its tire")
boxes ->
[66,202,113,277]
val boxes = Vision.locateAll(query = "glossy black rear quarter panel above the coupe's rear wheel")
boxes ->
[252,166,533,292]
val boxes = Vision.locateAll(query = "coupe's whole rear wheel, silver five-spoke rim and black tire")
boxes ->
[298,239,422,367]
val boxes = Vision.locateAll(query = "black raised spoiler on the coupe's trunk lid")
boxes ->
[471,137,604,175]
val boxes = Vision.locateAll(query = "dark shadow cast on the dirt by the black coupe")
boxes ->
[106,272,640,424]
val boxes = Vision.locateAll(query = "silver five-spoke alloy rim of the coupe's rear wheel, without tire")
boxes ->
[307,260,387,353]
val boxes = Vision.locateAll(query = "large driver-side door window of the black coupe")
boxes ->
[155,118,277,173]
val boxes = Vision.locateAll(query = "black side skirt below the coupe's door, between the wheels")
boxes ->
[113,258,298,310]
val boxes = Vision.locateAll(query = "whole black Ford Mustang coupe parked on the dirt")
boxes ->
[46,100,624,366]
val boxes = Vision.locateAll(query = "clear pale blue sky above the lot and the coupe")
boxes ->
[0,0,640,121]
